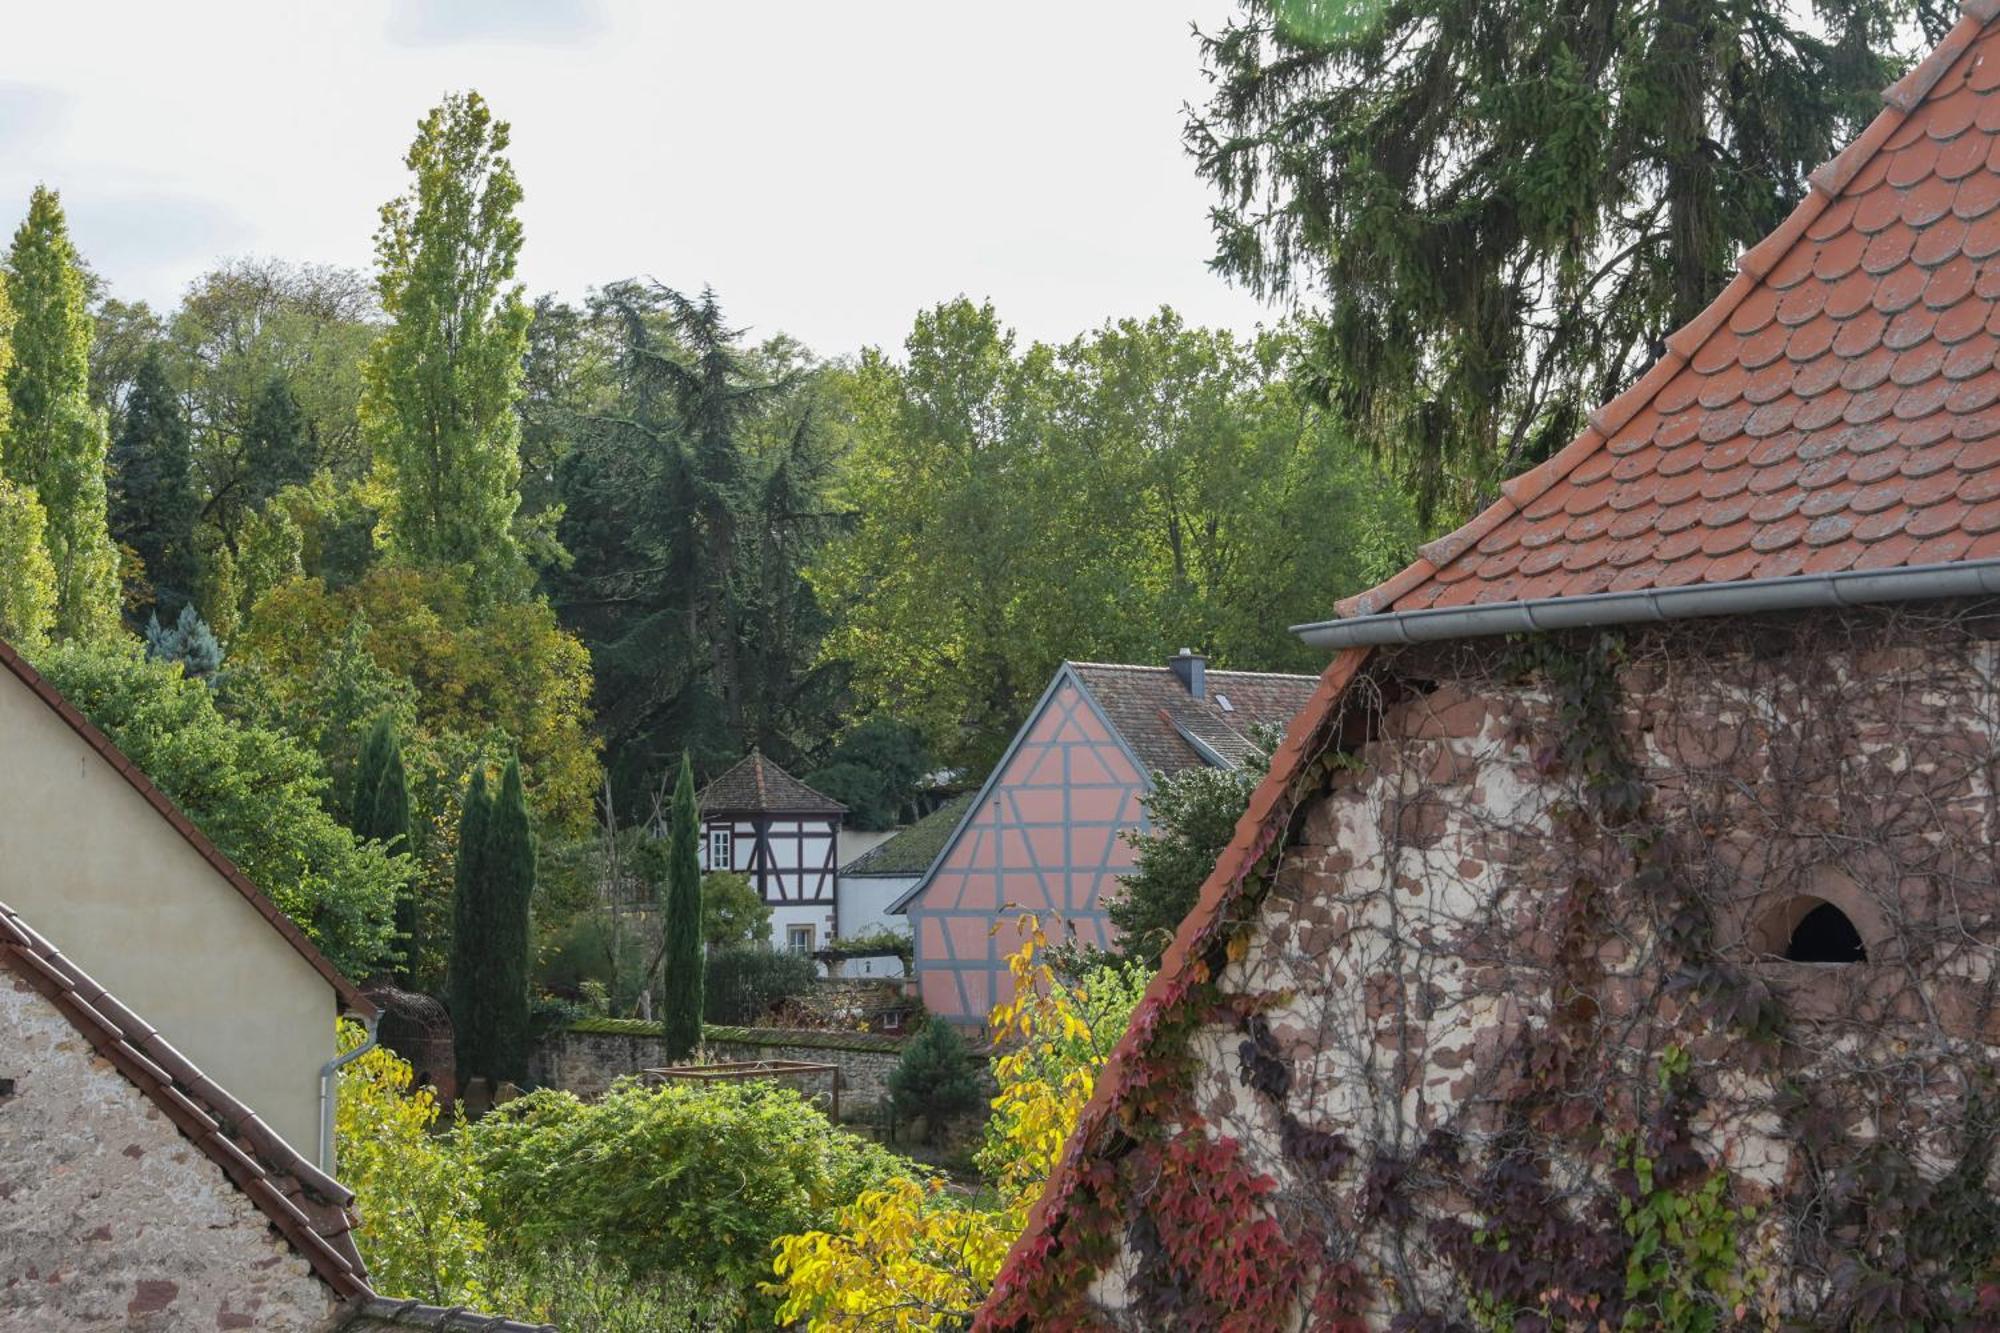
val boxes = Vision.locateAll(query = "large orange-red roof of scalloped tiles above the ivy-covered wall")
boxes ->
[1338,0,2000,616]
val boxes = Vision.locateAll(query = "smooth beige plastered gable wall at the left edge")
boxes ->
[0,671,336,1161]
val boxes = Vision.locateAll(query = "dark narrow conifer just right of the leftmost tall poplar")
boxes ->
[112,346,202,624]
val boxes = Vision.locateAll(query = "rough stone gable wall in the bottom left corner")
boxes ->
[0,960,342,1333]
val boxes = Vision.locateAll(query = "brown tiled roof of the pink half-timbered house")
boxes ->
[1068,662,1314,773]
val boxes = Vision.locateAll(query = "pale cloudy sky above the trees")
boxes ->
[0,0,1274,354]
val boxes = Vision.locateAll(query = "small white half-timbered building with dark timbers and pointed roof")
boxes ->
[702,751,848,953]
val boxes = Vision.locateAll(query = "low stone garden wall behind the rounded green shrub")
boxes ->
[530,1019,902,1119]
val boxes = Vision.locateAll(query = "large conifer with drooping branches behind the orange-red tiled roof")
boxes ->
[1186,0,1920,520]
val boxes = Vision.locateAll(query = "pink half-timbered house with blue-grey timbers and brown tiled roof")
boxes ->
[890,648,1316,1023]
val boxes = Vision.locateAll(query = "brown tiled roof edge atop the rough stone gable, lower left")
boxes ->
[0,903,374,1299]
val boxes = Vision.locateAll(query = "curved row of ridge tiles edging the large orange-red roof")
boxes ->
[1334,0,2000,618]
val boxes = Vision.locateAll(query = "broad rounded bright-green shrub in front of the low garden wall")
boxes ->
[456,1081,910,1291]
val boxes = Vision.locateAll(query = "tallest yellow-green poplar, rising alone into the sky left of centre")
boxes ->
[362,92,532,592]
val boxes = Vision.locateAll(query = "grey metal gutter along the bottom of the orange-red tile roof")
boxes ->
[1292,558,2000,648]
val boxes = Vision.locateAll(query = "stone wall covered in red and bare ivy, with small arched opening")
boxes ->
[1008,604,2000,1333]
